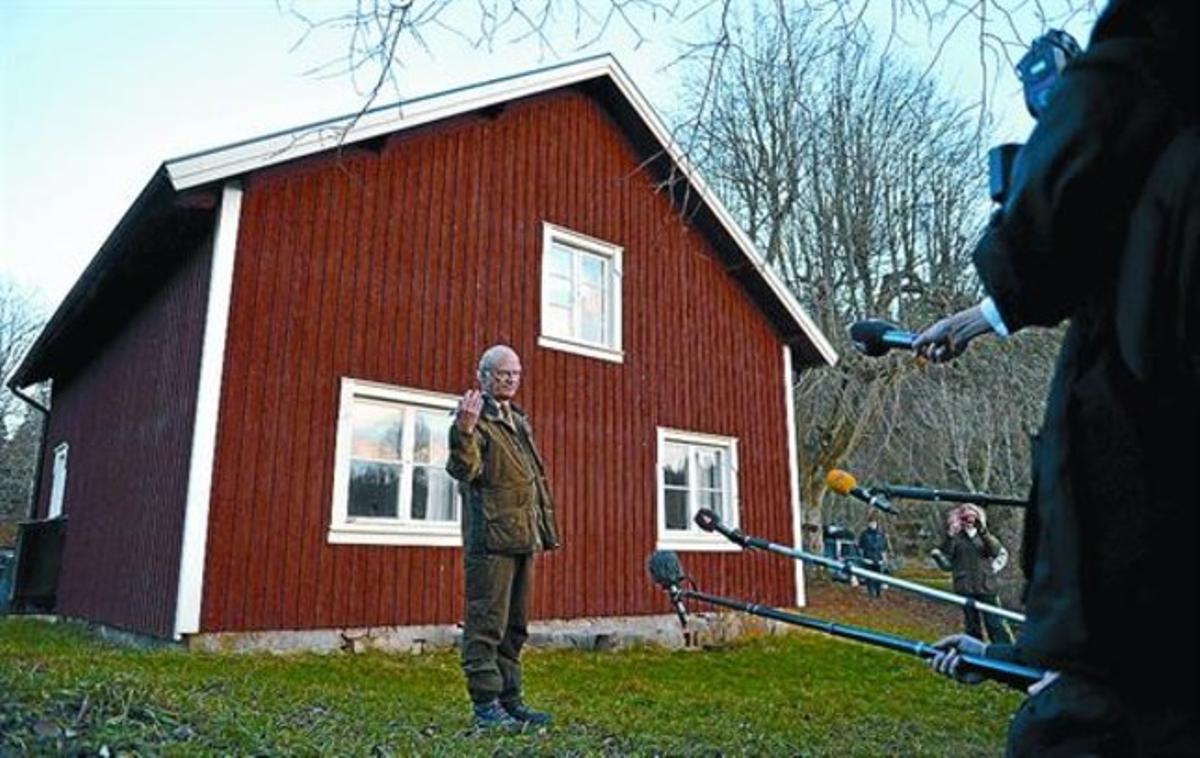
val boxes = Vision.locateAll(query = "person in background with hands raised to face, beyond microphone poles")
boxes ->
[930,503,1013,644]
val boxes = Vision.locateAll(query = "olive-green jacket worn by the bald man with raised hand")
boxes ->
[446,396,559,554]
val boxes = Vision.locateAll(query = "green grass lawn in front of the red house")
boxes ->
[0,580,1020,756]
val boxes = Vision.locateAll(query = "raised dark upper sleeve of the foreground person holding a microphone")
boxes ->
[974,40,1172,331]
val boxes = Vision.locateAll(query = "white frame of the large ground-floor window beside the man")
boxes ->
[328,377,466,547]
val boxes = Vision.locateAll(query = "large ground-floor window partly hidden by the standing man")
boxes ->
[329,379,462,546]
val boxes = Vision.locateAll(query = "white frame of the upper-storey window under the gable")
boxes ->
[538,222,625,363]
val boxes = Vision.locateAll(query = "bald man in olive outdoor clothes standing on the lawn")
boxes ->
[446,345,559,729]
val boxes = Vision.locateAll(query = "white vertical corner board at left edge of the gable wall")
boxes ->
[175,181,241,639]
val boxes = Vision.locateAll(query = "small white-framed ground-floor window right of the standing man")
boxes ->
[658,427,738,551]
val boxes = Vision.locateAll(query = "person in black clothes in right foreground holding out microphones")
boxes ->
[914,0,1200,754]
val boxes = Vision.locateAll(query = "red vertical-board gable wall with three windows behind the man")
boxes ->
[202,91,794,631]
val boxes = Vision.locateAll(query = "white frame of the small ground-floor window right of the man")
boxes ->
[654,427,742,553]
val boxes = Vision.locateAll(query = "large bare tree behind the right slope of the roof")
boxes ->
[684,12,986,539]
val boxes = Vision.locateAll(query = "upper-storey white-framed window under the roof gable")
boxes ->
[538,223,623,361]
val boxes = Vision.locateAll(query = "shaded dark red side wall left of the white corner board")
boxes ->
[38,241,211,637]
